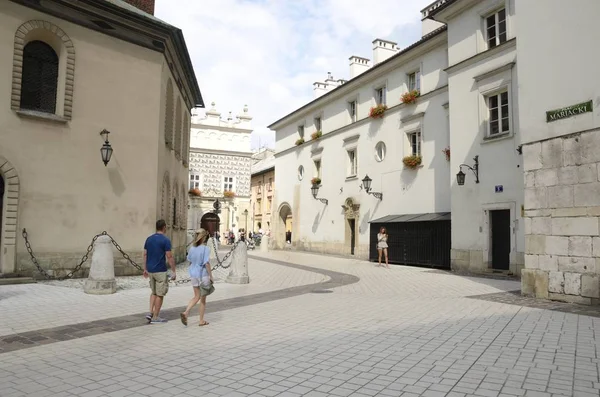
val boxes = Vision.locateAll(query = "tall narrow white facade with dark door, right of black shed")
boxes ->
[435,0,524,273]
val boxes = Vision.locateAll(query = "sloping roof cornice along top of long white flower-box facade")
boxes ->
[267,26,448,129]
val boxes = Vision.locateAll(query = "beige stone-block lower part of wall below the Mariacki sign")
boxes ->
[522,130,600,304]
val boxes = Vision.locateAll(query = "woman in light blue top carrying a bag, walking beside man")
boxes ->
[180,229,215,327]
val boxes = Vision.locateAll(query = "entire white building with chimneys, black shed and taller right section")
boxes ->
[270,0,524,273]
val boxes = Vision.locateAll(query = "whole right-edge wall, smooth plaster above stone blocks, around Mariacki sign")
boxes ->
[517,0,600,304]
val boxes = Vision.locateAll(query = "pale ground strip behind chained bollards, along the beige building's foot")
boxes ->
[38,251,231,291]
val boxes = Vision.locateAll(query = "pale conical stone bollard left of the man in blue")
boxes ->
[83,236,117,295]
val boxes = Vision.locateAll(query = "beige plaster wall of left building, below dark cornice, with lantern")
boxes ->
[0,2,189,272]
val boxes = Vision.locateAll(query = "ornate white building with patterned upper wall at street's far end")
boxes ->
[188,102,252,235]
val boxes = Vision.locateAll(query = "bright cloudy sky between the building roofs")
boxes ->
[155,0,433,149]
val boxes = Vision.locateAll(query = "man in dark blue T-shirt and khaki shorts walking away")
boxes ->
[144,219,176,324]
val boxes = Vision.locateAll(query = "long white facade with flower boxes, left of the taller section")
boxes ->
[270,29,450,258]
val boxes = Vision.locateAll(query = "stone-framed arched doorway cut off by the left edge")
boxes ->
[0,156,20,274]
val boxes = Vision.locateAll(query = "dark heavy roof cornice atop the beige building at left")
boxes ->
[11,0,204,110]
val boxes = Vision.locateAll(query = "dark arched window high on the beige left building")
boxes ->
[21,40,58,113]
